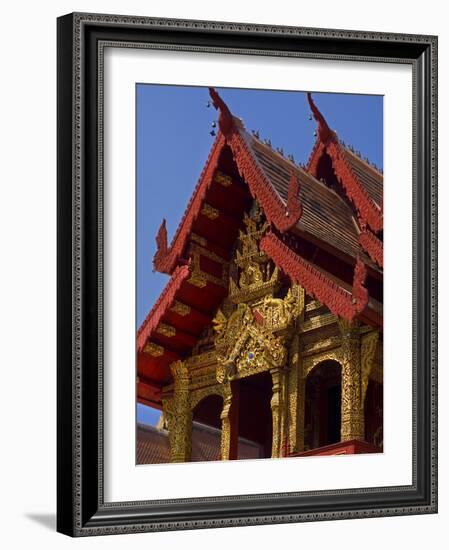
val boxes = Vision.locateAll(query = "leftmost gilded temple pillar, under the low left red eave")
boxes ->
[163,361,192,462]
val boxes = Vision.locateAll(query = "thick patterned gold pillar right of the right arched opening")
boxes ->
[339,321,365,441]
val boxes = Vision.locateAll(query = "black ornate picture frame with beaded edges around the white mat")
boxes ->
[57,13,437,536]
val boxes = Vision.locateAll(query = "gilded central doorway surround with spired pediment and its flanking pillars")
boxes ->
[207,206,305,458]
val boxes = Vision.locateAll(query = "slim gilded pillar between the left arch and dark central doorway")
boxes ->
[221,380,240,460]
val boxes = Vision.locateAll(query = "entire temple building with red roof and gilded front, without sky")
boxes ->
[136,88,383,464]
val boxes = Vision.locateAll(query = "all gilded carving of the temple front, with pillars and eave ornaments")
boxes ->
[157,199,381,462]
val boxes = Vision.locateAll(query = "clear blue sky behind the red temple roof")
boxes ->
[136,84,383,423]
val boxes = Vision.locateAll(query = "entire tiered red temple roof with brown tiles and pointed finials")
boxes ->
[137,89,383,404]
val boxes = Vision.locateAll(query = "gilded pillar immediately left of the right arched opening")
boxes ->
[286,334,306,453]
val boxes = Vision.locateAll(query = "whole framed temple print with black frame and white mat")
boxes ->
[58,14,437,536]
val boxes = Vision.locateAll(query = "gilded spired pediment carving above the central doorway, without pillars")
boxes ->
[213,205,304,382]
